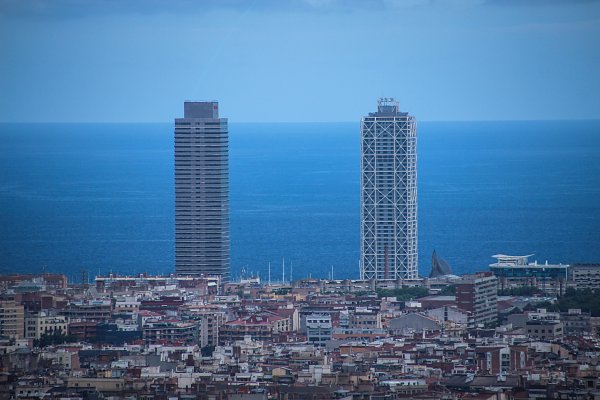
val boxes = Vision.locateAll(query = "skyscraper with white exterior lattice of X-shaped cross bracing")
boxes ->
[360,98,418,280]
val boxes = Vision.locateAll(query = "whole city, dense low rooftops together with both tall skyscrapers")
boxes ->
[0,98,600,400]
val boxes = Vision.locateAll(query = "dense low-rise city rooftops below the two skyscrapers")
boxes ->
[0,256,600,399]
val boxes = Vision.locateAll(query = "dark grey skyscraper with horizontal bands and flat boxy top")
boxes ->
[175,101,229,281]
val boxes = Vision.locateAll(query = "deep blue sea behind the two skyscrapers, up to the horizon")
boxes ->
[0,121,600,279]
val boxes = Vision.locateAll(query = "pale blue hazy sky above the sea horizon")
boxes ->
[0,0,600,122]
